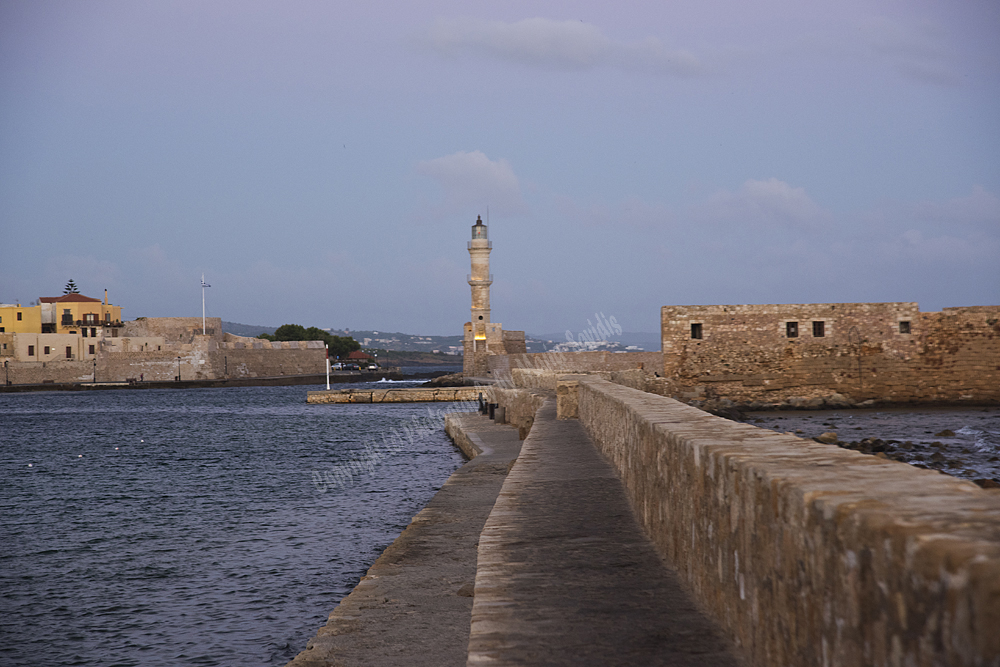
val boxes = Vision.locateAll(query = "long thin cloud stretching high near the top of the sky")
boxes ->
[426,18,706,76]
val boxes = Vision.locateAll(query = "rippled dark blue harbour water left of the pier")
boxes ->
[0,386,463,667]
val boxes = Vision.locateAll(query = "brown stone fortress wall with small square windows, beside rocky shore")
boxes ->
[661,303,1000,403]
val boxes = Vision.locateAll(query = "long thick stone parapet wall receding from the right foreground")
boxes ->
[572,376,1000,666]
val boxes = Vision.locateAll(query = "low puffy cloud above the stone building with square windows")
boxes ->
[692,178,832,228]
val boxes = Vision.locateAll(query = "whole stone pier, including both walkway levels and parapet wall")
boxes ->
[289,371,1000,667]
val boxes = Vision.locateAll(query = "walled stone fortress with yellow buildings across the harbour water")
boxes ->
[0,293,326,384]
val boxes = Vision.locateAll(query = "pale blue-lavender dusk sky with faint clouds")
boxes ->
[0,0,1000,335]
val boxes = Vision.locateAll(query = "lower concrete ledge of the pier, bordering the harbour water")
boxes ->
[288,413,521,667]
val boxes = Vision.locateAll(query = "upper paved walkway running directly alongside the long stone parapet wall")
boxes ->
[468,399,740,667]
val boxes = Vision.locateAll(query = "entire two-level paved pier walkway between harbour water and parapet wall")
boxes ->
[289,399,740,667]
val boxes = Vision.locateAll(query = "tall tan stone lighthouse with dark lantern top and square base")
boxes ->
[462,216,525,377]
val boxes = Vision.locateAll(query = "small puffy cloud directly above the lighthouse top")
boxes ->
[417,151,528,215]
